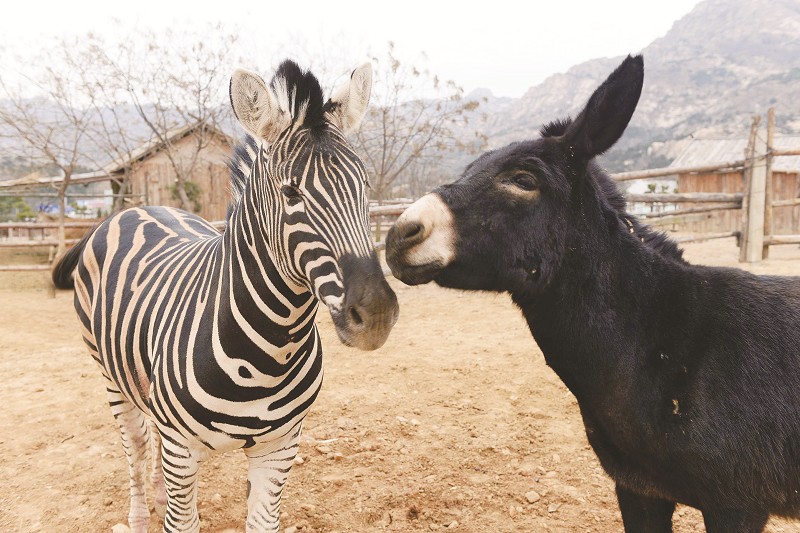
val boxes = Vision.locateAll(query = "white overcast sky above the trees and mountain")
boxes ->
[0,0,698,97]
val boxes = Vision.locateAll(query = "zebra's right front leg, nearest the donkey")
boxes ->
[244,423,302,533]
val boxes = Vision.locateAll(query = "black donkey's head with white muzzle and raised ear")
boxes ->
[386,56,643,295]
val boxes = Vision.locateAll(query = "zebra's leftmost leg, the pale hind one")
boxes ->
[107,384,150,533]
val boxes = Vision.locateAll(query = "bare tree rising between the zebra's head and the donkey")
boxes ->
[353,42,485,238]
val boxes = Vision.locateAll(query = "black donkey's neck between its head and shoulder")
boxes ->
[514,227,688,400]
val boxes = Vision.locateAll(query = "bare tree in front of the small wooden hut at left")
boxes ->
[93,26,237,209]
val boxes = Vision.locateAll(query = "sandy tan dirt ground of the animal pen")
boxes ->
[0,239,800,533]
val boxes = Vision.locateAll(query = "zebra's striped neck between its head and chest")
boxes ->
[217,183,318,365]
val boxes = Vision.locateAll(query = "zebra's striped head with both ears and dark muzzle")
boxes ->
[230,61,399,350]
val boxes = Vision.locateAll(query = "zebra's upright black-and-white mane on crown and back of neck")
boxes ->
[228,59,335,217]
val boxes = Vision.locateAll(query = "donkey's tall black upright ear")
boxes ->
[564,55,644,159]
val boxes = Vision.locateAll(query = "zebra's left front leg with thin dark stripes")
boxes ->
[159,427,200,533]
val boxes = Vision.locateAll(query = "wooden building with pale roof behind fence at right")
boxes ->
[670,136,800,235]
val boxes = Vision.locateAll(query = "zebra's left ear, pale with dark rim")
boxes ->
[230,69,291,143]
